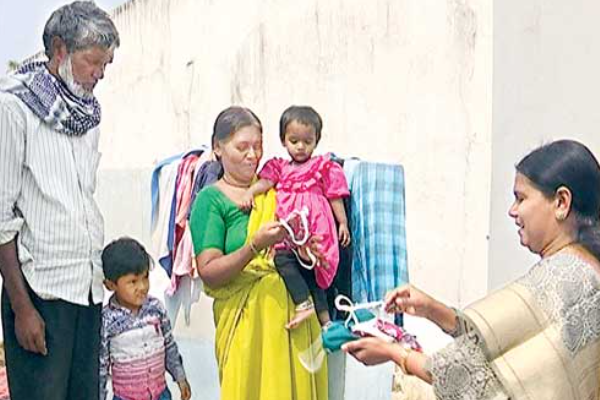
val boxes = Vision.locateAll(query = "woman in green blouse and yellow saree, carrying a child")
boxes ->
[191,107,327,400]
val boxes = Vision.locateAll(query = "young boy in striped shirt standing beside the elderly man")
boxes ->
[100,238,192,400]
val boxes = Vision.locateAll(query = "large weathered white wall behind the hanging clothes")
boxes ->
[99,0,492,305]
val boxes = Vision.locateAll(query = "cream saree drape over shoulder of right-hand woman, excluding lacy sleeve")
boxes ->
[464,253,600,400]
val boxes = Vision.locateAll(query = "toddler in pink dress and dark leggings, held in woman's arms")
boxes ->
[240,106,350,329]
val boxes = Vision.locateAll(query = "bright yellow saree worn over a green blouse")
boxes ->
[205,190,328,400]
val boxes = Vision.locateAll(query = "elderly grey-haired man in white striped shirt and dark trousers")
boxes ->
[0,1,119,400]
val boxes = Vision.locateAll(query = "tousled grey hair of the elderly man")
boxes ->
[42,1,120,59]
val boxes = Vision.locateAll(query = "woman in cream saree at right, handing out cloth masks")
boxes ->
[344,140,600,400]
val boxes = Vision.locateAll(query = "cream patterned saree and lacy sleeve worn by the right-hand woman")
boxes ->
[430,252,600,400]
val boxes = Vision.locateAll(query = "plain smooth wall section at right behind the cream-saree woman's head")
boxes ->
[489,0,600,288]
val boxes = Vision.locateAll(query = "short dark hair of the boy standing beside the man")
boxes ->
[102,237,152,283]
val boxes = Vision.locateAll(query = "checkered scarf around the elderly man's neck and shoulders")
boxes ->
[0,62,101,136]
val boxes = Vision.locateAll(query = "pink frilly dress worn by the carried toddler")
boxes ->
[259,154,350,289]
